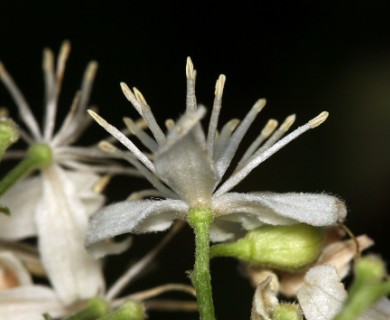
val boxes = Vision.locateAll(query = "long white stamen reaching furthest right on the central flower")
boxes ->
[214,112,328,197]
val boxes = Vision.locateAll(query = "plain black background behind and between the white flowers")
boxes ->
[0,1,390,319]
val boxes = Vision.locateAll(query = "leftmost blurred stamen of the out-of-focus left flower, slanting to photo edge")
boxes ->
[0,62,42,141]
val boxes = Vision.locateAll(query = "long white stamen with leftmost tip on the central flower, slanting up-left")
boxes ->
[88,110,156,173]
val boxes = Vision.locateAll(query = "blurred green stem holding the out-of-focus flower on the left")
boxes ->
[0,143,52,196]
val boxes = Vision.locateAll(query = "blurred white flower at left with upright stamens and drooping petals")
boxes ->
[0,42,134,305]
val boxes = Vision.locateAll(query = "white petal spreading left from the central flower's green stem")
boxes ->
[86,200,189,254]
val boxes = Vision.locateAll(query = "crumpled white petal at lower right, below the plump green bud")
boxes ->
[297,265,347,320]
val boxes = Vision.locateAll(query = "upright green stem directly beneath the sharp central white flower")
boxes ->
[187,208,215,320]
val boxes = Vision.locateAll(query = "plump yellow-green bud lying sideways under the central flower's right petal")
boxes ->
[210,224,325,271]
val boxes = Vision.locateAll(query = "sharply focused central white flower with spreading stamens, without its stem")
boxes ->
[86,59,346,251]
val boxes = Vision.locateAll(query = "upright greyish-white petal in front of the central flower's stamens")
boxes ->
[154,108,217,207]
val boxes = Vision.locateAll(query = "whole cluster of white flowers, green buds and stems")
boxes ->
[0,45,390,320]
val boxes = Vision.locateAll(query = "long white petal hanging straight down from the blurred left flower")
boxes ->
[36,166,104,304]
